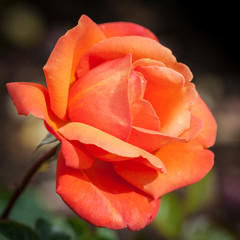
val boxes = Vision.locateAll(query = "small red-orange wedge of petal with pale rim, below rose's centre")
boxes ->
[128,127,186,152]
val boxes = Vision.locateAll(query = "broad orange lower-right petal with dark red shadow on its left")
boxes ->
[114,142,214,199]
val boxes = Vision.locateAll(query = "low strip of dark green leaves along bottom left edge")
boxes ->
[0,218,118,240]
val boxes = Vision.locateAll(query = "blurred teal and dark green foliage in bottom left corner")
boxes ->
[0,188,118,240]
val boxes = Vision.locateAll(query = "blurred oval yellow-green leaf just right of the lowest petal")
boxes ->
[153,193,184,238]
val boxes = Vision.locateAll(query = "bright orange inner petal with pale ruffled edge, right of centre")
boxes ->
[135,66,197,136]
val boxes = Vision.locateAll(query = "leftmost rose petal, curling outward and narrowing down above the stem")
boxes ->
[7,82,94,169]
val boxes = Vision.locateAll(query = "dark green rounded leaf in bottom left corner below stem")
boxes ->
[0,221,38,240]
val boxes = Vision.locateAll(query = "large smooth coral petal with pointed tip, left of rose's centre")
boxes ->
[68,55,131,140]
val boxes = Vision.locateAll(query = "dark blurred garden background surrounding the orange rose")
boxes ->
[0,0,240,240]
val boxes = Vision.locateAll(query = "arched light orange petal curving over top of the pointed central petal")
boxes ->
[78,36,176,71]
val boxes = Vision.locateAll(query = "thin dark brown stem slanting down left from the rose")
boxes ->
[0,146,58,220]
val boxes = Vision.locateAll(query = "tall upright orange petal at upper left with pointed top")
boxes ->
[43,15,105,119]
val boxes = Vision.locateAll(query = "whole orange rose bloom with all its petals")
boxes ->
[7,15,216,230]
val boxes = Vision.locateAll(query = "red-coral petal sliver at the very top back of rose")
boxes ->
[99,22,158,41]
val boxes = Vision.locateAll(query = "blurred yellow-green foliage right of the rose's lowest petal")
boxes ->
[153,171,239,240]
